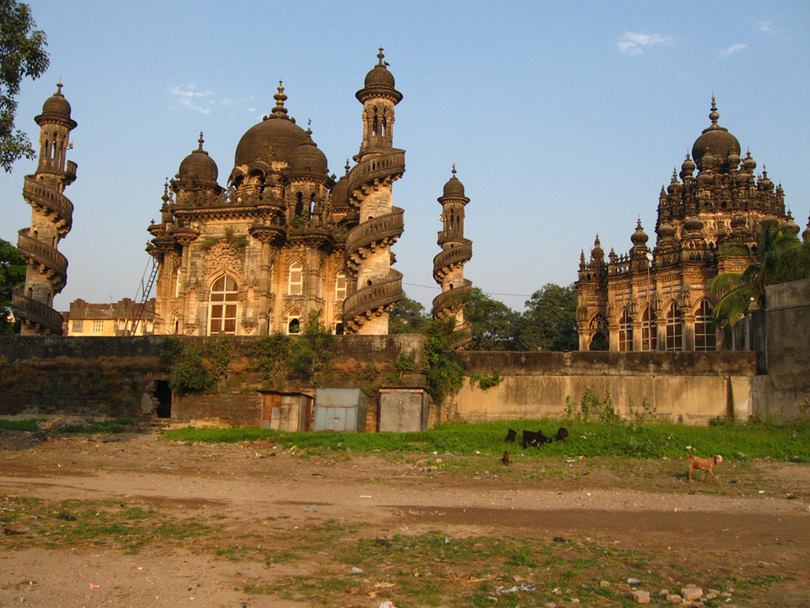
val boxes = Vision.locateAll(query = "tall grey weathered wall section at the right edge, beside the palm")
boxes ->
[754,279,810,419]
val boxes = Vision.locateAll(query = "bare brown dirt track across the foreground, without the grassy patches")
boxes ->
[0,434,810,608]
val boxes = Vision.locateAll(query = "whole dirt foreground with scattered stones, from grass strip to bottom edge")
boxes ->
[0,431,810,608]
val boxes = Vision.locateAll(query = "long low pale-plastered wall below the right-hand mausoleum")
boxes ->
[442,352,756,423]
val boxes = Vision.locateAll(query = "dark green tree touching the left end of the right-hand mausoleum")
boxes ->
[519,283,579,351]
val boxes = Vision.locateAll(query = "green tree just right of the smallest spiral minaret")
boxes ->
[464,287,520,350]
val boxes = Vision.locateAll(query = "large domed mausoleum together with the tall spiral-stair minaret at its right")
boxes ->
[147,49,405,336]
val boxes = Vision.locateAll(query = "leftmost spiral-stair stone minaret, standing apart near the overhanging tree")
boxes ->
[12,83,76,336]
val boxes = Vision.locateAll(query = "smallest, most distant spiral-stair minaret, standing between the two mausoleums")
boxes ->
[433,165,472,343]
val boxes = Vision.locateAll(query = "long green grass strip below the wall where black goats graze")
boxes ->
[163,419,810,462]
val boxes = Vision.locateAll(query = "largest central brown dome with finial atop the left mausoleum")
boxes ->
[234,81,307,166]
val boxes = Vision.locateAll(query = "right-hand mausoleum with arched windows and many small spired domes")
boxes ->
[577,97,799,351]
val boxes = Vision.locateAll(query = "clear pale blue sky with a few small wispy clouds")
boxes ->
[0,0,810,309]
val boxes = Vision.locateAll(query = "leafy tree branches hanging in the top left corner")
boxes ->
[0,0,48,173]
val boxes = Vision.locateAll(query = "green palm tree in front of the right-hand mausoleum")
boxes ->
[709,220,810,328]
